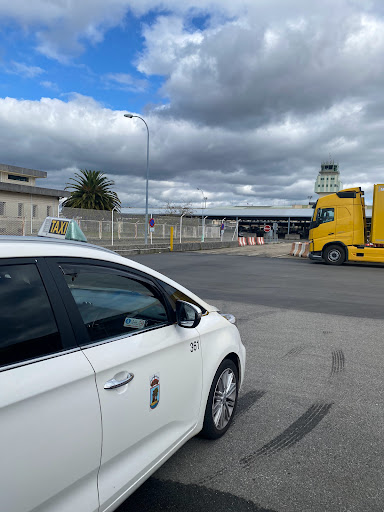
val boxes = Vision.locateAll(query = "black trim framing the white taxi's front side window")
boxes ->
[45,256,176,349]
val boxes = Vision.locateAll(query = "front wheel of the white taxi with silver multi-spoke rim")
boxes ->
[201,359,239,439]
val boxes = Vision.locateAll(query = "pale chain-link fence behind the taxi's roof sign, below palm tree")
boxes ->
[0,202,237,246]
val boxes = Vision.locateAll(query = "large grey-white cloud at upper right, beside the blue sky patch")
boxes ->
[138,11,384,130]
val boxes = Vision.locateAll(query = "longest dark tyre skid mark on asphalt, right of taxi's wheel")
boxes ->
[240,402,333,468]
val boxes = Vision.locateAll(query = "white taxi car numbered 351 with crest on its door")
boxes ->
[0,228,245,512]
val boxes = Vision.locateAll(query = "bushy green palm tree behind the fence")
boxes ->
[63,169,121,211]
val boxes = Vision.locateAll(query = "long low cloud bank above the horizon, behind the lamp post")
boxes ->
[0,94,383,207]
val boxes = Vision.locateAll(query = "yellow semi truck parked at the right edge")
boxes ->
[309,185,384,265]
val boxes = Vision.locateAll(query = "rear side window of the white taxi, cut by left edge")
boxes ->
[0,263,63,366]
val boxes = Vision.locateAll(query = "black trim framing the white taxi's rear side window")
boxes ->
[0,257,79,372]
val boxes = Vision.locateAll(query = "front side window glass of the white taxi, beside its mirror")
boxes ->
[60,264,168,341]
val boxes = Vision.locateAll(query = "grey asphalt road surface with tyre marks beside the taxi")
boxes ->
[119,253,384,512]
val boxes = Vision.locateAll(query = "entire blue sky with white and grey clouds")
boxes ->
[0,0,384,208]
